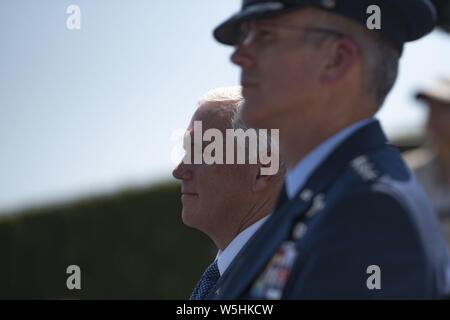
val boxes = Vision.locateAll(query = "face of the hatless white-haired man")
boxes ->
[173,104,258,234]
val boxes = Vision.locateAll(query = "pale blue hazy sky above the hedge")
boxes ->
[0,0,450,211]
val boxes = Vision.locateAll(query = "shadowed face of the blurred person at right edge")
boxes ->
[428,100,450,150]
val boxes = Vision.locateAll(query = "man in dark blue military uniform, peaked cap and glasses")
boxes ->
[208,0,448,299]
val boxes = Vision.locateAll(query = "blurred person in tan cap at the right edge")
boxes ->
[406,78,450,245]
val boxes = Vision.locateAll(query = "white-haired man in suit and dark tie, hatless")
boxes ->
[173,87,282,300]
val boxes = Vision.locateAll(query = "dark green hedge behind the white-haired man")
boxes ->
[0,184,215,299]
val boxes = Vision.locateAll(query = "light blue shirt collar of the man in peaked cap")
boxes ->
[285,118,375,199]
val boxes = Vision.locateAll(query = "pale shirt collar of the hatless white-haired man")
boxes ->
[216,215,270,276]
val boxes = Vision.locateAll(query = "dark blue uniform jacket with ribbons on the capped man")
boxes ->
[209,121,449,299]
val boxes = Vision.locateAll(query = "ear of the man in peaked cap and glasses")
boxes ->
[320,38,359,84]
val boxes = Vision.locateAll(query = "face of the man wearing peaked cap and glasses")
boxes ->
[231,10,321,127]
